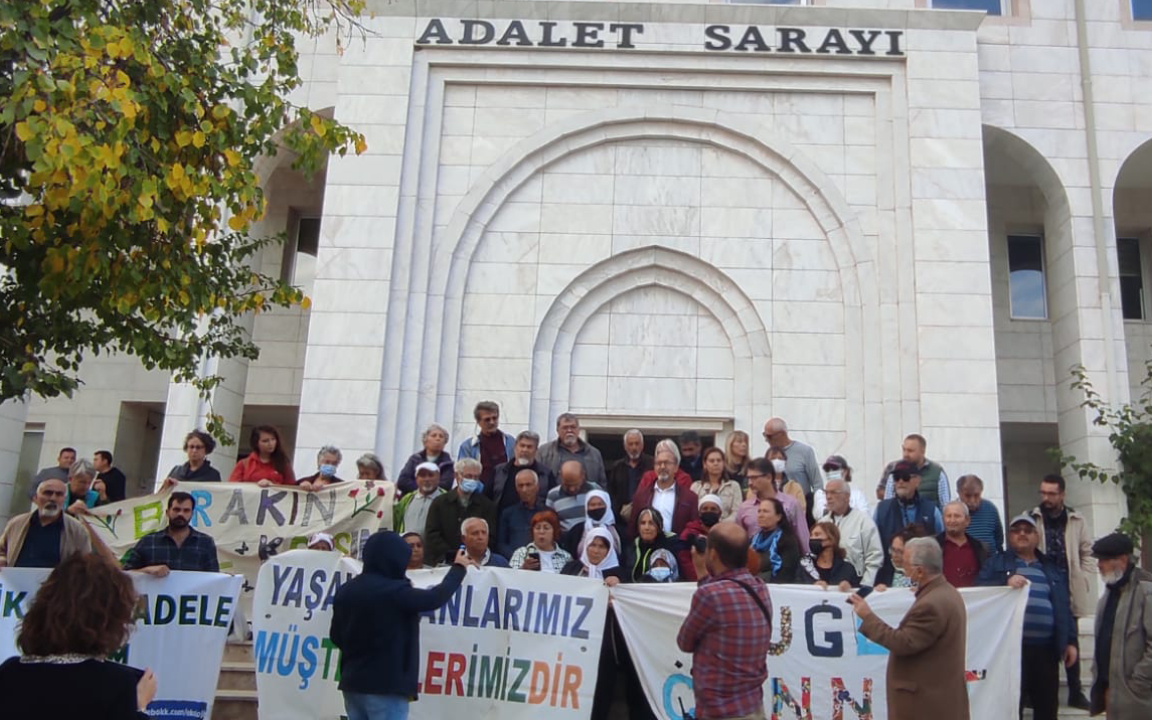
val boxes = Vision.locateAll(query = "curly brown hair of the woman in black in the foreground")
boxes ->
[16,553,137,658]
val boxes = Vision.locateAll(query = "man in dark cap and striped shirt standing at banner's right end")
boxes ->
[976,514,1077,720]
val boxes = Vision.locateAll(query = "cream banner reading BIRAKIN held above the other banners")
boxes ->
[88,482,395,602]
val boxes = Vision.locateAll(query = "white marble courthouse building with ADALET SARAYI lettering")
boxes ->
[0,0,1152,541]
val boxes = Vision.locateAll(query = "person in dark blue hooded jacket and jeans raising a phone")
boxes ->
[329,530,475,720]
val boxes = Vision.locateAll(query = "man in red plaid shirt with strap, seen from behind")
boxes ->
[676,522,772,720]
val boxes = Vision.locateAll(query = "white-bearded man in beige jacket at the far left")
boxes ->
[0,478,94,568]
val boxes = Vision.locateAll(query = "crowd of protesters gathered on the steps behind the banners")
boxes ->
[0,401,1152,720]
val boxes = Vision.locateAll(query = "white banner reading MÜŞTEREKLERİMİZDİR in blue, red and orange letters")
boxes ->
[252,551,608,720]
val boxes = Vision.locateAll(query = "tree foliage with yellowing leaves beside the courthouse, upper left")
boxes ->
[0,0,365,440]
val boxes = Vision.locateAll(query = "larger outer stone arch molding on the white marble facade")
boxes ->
[419,106,880,427]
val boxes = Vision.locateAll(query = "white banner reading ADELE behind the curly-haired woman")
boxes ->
[0,568,242,720]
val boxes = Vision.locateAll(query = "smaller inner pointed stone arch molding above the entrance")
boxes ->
[529,245,772,427]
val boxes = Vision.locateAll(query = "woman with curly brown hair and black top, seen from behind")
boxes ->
[0,553,157,720]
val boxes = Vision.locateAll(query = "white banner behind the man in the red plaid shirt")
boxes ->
[612,584,1028,720]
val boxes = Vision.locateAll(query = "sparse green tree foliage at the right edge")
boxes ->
[1055,361,1152,543]
